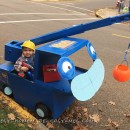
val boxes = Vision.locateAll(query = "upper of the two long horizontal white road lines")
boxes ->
[0,13,85,15]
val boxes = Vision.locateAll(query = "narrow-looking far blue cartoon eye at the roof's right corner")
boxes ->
[87,42,97,60]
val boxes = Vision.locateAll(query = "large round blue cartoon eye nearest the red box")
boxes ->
[57,57,75,80]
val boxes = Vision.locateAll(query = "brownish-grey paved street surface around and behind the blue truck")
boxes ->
[0,0,130,130]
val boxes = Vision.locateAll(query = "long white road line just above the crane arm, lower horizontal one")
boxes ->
[0,18,97,24]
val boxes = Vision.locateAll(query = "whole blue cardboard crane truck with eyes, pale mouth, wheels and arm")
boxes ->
[0,13,130,119]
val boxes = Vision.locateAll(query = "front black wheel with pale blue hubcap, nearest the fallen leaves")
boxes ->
[35,104,51,119]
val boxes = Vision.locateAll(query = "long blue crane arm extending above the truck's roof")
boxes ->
[26,13,130,45]
